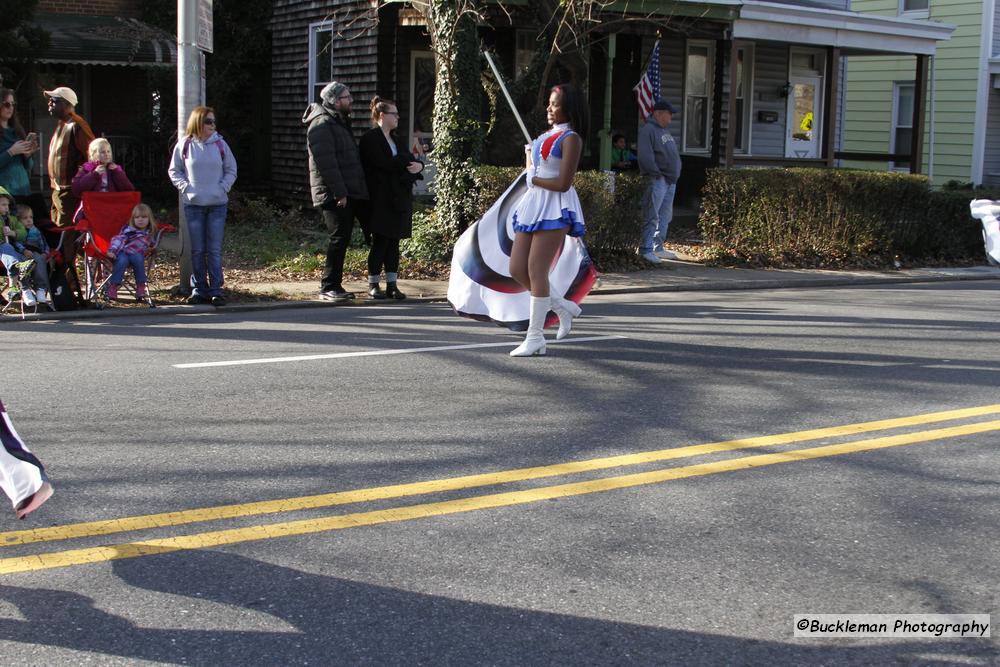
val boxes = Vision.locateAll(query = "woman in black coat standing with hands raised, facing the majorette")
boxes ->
[360,95,424,299]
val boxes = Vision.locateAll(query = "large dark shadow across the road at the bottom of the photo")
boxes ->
[0,551,1000,665]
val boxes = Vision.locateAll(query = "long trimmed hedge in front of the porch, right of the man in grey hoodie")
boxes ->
[699,168,982,267]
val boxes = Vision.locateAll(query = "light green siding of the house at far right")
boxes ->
[841,0,995,185]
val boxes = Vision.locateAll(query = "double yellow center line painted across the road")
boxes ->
[0,404,1000,574]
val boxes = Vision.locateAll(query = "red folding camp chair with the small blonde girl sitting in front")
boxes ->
[75,192,175,309]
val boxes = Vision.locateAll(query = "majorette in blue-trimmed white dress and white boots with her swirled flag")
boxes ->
[448,84,597,357]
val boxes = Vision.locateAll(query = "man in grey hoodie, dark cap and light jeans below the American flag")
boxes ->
[637,100,681,264]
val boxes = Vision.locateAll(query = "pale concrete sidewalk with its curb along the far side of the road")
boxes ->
[0,261,1000,322]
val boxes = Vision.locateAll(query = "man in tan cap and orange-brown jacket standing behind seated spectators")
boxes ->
[45,86,94,288]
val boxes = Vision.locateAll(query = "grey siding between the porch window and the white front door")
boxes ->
[750,42,788,157]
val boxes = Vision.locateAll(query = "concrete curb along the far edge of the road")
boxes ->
[0,272,1000,325]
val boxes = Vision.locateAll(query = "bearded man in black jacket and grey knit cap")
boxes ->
[302,81,368,301]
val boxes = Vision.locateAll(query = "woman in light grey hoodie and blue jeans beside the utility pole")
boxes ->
[169,107,236,306]
